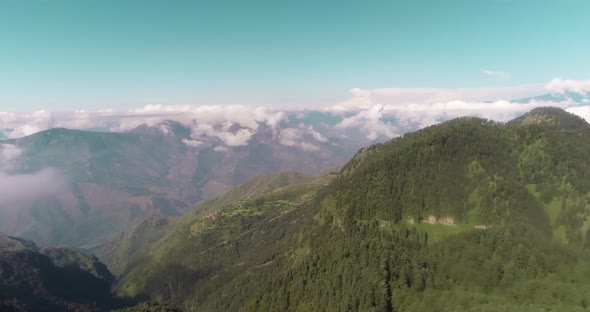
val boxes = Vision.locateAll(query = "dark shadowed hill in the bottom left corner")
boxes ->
[0,233,114,311]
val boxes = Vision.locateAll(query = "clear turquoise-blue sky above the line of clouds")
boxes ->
[0,0,590,111]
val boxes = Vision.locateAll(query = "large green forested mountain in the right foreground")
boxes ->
[116,108,590,311]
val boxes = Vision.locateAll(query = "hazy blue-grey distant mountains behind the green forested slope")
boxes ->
[0,121,359,249]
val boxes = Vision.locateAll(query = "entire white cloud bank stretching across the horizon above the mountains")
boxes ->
[0,78,590,143]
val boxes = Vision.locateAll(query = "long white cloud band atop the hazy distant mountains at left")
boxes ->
[0,105,286,147]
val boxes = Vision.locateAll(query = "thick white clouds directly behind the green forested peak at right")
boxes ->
[325,79,590,140]
